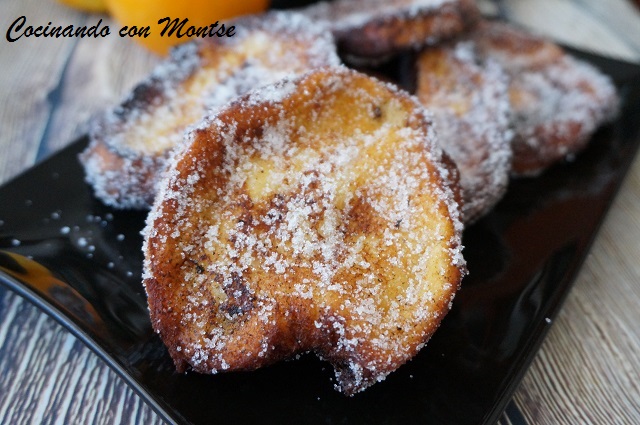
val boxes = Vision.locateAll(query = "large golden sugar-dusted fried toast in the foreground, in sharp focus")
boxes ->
[144,68,465,394]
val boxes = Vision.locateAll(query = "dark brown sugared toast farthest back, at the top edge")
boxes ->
[303,0,480,58]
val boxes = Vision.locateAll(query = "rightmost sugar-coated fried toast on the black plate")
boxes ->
[473,22,618,175]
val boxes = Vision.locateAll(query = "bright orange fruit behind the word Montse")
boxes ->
[106,0,270,55]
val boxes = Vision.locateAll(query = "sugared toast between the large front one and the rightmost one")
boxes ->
[416,41,512,223]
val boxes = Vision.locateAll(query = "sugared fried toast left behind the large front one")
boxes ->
[81,12,340,208]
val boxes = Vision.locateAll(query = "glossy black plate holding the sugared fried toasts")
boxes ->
[0,48,640,425]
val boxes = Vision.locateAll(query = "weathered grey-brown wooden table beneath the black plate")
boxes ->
[0,0,640,424]
